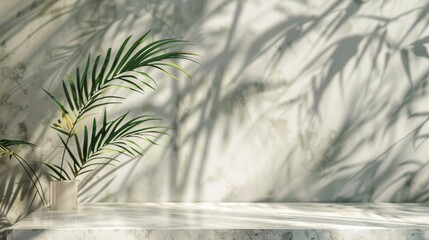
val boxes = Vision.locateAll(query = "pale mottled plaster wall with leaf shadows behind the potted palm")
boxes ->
[0,0,429,236]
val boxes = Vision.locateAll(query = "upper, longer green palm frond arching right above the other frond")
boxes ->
[47,32,196,130]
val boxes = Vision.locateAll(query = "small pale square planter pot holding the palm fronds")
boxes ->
[49,181,78,210]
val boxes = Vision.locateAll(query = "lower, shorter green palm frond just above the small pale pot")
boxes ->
[49,111,166,180]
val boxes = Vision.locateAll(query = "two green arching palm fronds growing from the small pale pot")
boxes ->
[44,32,195,180]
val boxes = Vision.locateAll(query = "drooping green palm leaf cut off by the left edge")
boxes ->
[0,139,46,204]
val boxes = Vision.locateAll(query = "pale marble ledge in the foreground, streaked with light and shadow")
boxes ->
[8,203,429,240]
